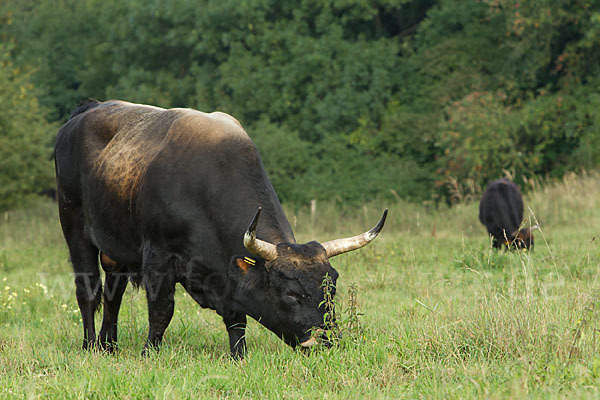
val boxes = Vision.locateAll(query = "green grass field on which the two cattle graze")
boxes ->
[0,174,600,399]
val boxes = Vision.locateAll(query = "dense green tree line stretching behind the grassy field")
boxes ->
[0,0,600,208]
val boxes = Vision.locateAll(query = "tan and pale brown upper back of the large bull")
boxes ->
[57,101,245,203]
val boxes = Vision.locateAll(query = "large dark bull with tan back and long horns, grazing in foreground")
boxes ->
[55,101,387,357]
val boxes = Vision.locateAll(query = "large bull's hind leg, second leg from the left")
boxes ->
[100,260,129,353]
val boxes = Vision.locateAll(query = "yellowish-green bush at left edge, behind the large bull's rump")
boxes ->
[0,44,53,210]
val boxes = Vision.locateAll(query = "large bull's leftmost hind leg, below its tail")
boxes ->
[59,199,102,349]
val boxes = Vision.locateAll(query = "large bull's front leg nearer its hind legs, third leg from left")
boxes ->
[142,247,175,355]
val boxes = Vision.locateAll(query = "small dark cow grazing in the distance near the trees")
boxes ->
[479,179,537,249]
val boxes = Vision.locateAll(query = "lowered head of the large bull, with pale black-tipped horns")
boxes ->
[236,208,387,347]
